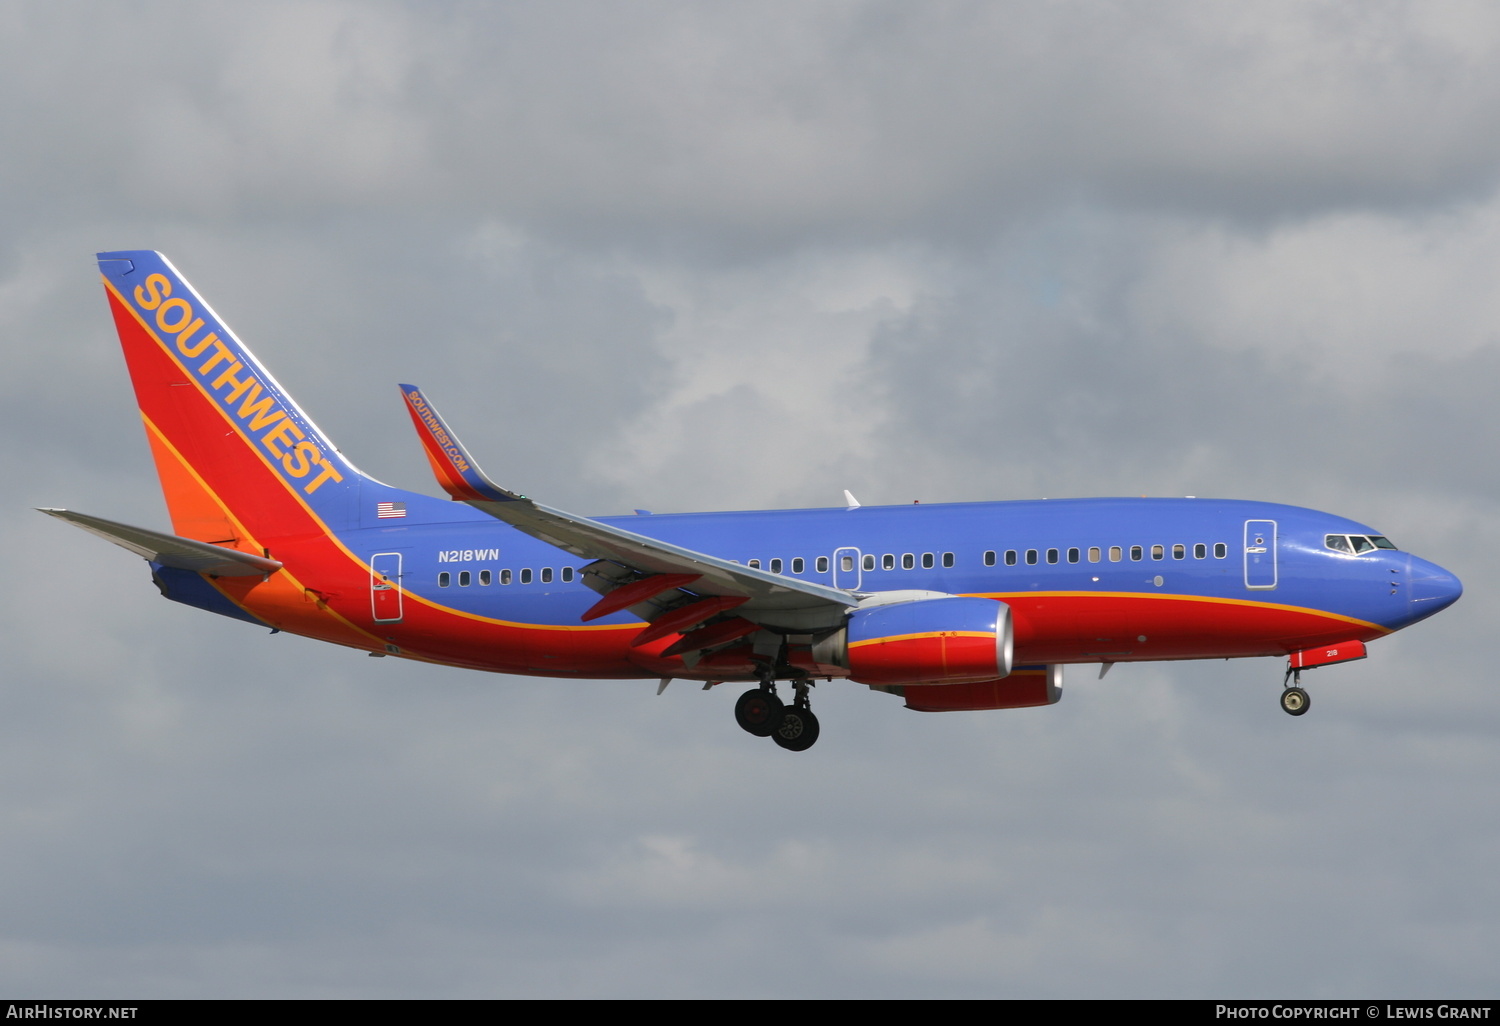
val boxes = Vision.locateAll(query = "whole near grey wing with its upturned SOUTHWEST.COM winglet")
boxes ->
[401,384,861,630]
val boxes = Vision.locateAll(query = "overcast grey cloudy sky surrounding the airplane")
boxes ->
[0,0,1500,998]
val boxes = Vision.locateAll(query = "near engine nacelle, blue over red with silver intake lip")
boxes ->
[813,596,1016,686]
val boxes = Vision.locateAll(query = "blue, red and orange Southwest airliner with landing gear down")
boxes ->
[44,251,1463,752]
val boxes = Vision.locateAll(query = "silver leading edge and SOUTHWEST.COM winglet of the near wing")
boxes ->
[401,384,861,614]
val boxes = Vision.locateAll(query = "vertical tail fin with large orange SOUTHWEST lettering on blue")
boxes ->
[99,251,363,548]
